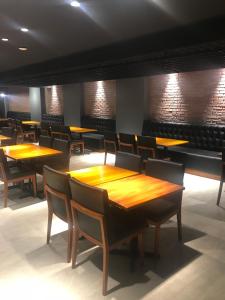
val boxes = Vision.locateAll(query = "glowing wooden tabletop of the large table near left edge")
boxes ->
[2,144,62,160]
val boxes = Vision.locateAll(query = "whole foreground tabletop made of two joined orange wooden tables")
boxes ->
[68,165,184,210]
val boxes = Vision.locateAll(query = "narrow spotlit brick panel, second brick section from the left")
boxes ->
[45,85,63,115]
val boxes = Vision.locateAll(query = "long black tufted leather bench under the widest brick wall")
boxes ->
[142,120,225,175]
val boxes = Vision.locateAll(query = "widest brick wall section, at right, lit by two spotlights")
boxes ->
[148,69,225,124]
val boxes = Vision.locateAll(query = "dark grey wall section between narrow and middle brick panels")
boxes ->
[63,84,83,126]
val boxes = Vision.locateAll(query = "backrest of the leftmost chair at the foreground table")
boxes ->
[43,166,71,221]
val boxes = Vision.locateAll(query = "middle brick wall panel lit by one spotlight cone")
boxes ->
[84,80,116,119]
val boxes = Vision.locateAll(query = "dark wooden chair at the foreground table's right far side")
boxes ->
[143,159,184,255]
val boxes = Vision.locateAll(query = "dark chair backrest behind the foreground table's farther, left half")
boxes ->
[115,151,141,172]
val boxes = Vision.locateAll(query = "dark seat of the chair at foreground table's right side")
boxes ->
[143,199,177,222]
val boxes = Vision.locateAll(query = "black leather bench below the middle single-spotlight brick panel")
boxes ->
[81,116,116,151]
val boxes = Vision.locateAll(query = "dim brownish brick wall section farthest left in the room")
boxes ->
[6,87,30,112]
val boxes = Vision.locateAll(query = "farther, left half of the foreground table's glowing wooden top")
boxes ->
[68,165,138,186]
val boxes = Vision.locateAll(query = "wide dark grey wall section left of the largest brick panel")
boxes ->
[116,77,147,134]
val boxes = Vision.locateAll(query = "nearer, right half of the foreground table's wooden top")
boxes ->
[98,174,184,210]
